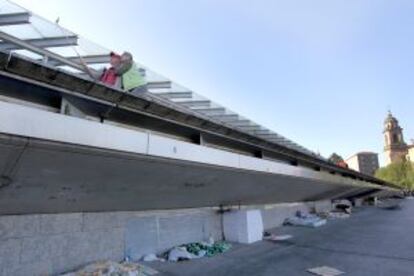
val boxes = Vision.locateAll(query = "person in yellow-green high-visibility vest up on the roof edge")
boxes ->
[114,52,147,94]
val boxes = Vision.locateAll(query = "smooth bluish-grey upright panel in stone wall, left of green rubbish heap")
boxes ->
[125,216,159,260]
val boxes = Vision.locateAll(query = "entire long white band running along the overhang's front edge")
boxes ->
[0,101,384,190]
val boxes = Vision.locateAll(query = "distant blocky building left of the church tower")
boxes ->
[346,152,379,175]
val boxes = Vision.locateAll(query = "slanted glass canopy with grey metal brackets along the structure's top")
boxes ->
[0,0,320,157]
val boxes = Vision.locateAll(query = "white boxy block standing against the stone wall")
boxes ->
[223,210,263,243]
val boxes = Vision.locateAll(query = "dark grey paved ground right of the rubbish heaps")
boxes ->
[151,200,414,276]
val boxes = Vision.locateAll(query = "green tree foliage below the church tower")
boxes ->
[375,161,414,190]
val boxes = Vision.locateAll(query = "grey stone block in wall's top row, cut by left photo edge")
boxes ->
[0,215,40,240]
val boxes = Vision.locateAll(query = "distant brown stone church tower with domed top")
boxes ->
[383,112,414,166]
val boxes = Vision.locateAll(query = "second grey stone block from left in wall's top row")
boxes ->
[39,213,82,235]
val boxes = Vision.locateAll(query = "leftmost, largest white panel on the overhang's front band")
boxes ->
[0,101,148,154]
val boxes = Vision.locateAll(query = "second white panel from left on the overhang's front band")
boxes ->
[148,134,239,168]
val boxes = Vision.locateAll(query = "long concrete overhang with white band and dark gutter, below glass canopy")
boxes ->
[0,51,392,214]
